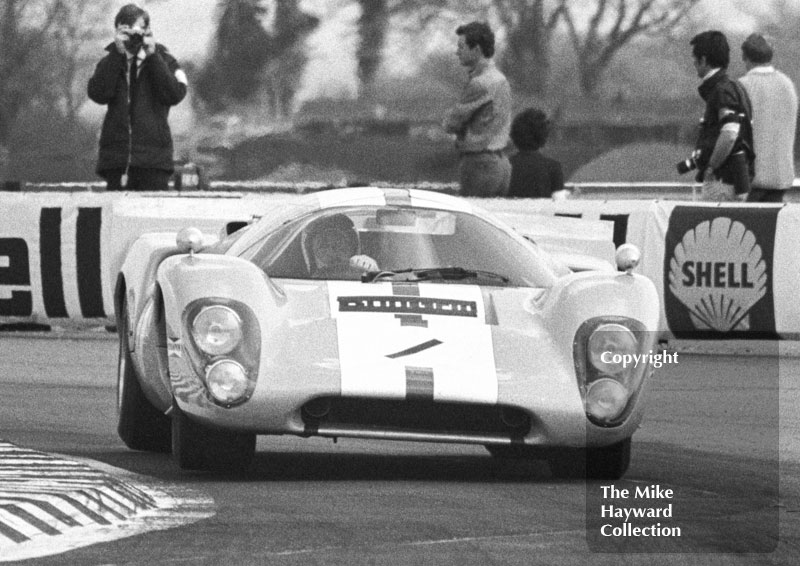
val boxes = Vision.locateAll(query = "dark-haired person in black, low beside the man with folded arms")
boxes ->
[508,108,567,200]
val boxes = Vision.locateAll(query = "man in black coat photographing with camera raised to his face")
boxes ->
[88,4,187,191]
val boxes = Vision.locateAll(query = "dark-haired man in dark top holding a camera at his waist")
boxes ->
[678,31,755,200]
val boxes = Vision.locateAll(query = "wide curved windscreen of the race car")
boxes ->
[241,206,555,287]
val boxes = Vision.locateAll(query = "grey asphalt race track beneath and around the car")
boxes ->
[0,332,800,566]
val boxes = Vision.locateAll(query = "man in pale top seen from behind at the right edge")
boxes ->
[739,33,797,202]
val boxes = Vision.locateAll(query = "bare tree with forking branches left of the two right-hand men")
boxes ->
[560,0,700,97]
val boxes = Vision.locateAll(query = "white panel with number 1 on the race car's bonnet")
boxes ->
[328,281,497,403]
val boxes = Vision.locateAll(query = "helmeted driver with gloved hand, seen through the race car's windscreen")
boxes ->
[306,214,378,279]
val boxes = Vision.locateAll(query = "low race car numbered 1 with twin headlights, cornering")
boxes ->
[115,187,659,478]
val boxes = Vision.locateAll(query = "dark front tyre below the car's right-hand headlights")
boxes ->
[548,438,631,480]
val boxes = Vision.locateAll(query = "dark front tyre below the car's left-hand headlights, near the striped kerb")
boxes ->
[171,403,256,472]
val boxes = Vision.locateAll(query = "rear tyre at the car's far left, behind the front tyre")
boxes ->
[117,303,170,452]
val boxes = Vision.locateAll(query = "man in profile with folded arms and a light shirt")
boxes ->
[443,22,511,197]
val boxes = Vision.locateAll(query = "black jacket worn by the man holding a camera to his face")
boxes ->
[88,43,186,175]
